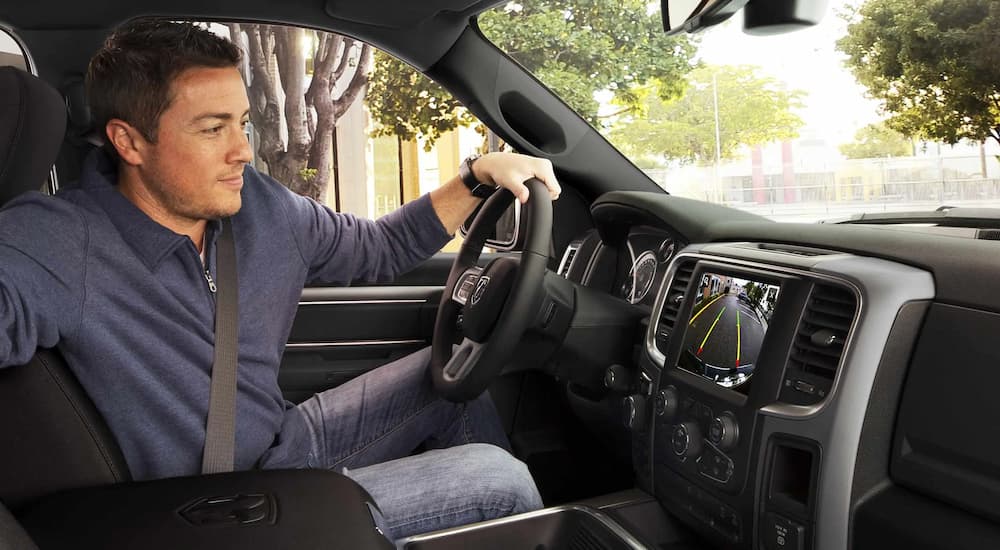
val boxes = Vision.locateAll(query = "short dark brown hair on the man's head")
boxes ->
[86,18,241,146]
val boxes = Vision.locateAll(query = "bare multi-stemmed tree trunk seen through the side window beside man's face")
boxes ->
[228,23,371,199]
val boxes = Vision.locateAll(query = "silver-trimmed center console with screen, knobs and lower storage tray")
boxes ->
[390,243,934,550]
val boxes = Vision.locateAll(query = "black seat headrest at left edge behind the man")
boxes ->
[0,67,66,206]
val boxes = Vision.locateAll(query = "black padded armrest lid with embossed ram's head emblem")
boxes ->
[17,470,392,550]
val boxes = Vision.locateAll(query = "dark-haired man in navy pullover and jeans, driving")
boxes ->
[0,20,559,538]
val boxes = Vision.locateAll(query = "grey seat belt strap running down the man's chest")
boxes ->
[201,218,239,474]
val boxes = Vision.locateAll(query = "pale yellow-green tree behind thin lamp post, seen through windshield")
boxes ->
[611,65,803,164]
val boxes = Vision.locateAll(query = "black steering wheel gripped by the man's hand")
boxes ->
[431,178,552,402]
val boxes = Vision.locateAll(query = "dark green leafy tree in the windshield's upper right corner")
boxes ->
[837,0,1000,144]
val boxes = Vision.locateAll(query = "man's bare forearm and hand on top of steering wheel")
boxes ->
[430,153,562,234]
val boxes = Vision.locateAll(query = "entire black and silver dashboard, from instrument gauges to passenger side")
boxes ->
[560,192,1000,550]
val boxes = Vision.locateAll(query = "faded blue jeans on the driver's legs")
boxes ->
[299,348,542,539]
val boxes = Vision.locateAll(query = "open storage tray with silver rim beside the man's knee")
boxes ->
[401,506,643,550]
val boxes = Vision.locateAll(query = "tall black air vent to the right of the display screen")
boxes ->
[781,284,858,405]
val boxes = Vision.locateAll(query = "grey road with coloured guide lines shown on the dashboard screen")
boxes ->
[684,294,764,368]
